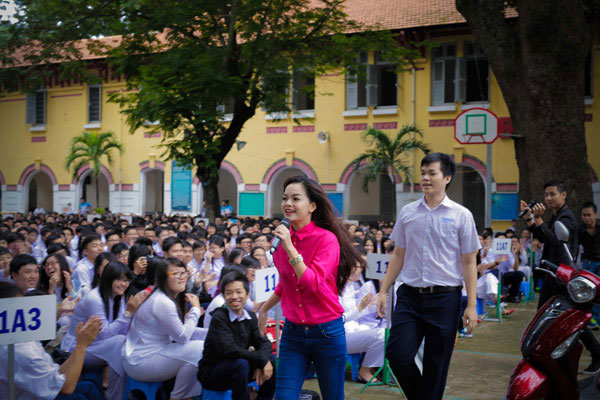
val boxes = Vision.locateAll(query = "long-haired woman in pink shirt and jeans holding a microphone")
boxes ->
[259,176,363,400]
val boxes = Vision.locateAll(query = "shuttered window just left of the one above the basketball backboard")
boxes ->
[431,43,456,105]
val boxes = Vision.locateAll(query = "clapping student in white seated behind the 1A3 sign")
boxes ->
[0,282,103,400]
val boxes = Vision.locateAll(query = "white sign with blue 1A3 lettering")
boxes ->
[0,295,56,345]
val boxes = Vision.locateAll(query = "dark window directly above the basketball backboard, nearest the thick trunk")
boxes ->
[459,42,490,103]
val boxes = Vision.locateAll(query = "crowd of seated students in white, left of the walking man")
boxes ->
[0,213,393,399]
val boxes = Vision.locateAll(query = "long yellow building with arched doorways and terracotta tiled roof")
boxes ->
[0,0,600,229]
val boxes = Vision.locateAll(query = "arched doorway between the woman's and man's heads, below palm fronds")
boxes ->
[344,170,396,222]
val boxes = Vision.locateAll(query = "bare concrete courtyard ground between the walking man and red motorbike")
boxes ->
[304,301,600,400]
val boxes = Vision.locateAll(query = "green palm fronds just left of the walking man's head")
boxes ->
[352,125,431,193]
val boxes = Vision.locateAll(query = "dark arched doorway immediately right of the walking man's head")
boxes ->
[447,164,485,232]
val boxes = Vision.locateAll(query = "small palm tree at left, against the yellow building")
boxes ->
[65,131,123,207]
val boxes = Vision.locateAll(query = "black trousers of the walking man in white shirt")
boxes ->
[386,285,461,400]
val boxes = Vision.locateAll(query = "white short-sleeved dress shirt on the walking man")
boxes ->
[391,196,481,287]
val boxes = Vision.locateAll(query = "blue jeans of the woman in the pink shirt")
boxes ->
[275,317,346,400]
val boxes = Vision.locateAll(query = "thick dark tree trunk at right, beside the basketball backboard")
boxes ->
[456,0,593,222]
